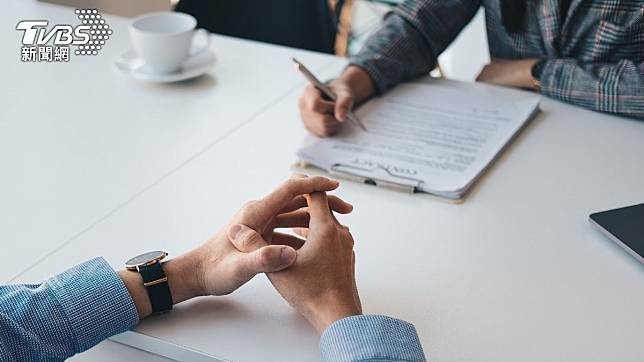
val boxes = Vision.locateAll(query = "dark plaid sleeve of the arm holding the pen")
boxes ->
[350,0,481,93]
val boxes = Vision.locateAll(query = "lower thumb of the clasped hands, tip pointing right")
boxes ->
[234,245,297,279]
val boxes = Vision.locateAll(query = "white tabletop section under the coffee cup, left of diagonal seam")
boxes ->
[0,0,334,282]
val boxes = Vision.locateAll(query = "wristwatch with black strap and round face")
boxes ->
[125,251,173,314]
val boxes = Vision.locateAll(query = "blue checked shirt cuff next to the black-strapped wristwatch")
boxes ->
[47,258,139,353]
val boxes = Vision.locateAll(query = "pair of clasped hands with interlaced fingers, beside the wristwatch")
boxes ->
[168,175,362,332]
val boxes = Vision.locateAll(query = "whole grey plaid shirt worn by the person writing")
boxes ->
[351,0,644,118]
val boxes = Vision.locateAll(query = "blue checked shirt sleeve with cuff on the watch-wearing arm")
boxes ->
[0,258,139,361]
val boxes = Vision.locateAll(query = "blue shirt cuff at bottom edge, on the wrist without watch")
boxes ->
[320,315,425,362]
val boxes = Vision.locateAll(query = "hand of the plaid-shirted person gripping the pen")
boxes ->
[298,66,375,137]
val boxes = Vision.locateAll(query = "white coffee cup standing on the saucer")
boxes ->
[130,11,210,74]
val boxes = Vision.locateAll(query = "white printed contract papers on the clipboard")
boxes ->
[298,83,539,199]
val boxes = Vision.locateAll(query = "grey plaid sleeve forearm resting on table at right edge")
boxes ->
[539,59,644,118]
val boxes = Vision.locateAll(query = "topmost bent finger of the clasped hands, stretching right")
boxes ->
[259,175,340,215]
